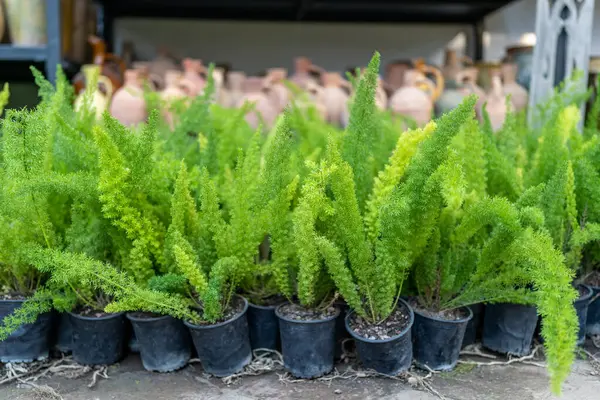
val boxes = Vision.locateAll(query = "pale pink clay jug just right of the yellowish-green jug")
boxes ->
[110,69,148,126]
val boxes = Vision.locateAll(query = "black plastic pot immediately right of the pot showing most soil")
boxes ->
[412,307,473,371]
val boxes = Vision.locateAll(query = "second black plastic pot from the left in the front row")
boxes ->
[69,313,127,365]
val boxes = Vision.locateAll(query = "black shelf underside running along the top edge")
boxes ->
[98,0,512,23]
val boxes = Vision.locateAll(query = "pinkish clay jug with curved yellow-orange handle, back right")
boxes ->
[389,62,444,126]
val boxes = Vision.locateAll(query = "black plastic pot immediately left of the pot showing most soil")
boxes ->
[275,306,340,379]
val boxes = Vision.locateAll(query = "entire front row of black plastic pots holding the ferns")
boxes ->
[0,282,600,378]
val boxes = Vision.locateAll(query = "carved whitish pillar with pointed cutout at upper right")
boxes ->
[529,0,594,124]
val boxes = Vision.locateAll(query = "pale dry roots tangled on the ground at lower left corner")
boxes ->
[0,356,108,392]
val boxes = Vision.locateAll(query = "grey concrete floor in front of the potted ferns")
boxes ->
[0,349,600,400]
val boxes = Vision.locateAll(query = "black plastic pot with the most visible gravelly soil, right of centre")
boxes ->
[346,299,415,375]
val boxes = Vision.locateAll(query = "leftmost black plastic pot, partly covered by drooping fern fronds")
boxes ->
[0,300,52,362]
